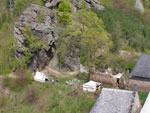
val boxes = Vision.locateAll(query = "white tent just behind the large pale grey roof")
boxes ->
[83,80,101,92]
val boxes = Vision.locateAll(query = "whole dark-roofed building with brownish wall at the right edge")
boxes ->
[129,54,150,91]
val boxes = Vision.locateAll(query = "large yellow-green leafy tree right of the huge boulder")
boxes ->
[58,10,111,69]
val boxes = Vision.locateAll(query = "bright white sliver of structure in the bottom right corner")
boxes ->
[140,92,150,113]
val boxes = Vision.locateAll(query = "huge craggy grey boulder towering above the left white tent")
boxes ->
[14,4,58,71]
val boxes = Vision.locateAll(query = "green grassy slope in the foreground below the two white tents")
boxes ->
[0,79,97,113]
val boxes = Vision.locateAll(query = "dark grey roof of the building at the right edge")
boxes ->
[131,54,150,78]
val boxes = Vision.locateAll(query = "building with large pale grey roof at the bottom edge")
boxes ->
[90,88,141,113]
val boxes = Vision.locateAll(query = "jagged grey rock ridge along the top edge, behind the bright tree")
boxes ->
[43,0,104,12]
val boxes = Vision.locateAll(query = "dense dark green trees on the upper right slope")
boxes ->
[96,7,150,51]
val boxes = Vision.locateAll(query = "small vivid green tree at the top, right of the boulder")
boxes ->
[58,0,72,23]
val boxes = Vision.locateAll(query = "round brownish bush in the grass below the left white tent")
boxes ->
[24,85,39,104]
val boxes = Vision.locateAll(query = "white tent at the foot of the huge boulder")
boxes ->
[34,71,48,82]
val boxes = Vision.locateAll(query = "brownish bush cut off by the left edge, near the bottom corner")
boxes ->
[0,89,10,108]
